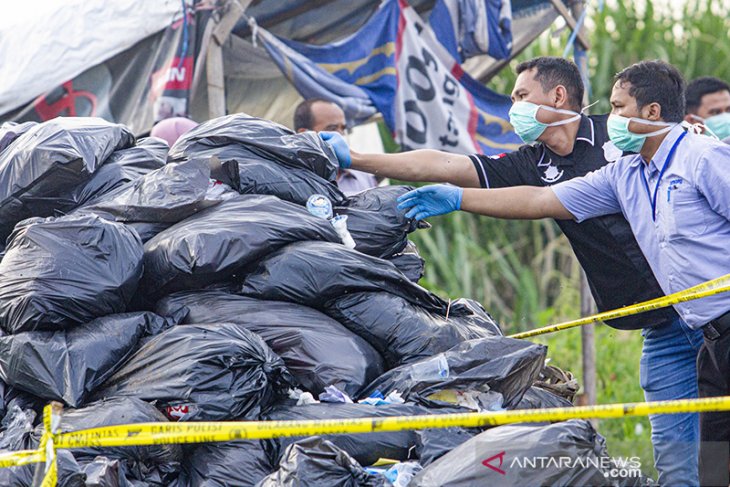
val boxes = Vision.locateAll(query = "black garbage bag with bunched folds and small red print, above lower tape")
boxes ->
[95,323,292,421]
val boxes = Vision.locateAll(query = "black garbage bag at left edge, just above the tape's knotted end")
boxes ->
[0,313,169,407]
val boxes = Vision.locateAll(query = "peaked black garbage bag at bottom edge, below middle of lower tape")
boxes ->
[257,436,388,487]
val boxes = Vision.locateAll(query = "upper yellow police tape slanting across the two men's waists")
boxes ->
[509,274,730,338]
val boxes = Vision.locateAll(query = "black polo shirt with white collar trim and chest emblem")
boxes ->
[470,115,677,329]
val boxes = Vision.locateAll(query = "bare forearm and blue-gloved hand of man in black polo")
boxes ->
[320,132,479,187]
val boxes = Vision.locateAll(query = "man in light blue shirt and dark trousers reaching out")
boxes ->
[400,61,730,486]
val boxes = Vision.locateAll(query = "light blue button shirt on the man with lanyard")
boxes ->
[552,125,730,328]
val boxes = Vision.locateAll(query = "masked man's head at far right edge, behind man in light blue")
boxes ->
[684,76,730,144]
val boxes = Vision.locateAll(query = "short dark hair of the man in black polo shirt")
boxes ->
[516,56,585,111]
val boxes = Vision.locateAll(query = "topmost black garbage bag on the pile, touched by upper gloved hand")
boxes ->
[169,113,339,181]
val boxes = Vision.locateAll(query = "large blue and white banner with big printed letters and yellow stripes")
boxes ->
[257,0,521,155]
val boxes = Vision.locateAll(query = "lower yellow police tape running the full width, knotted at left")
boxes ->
[0,396,730,487]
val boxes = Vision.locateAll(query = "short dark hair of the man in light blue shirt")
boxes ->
[615,59,685,123]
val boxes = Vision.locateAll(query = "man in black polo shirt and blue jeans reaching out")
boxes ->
[323,57,703,486]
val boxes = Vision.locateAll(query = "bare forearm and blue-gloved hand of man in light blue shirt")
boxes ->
[398,184,573,220]
